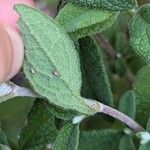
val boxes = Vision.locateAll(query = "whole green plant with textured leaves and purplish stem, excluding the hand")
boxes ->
[0,0,150,150]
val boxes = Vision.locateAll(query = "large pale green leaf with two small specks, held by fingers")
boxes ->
[15,5,95,114]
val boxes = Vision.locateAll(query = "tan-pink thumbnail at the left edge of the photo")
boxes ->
[0,25,13,83]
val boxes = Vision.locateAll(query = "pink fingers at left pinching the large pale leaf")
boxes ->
[0,0,34,83]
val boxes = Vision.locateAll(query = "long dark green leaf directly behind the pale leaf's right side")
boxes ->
[79,37,113,105]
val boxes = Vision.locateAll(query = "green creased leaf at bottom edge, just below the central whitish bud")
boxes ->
[54,123,79,150]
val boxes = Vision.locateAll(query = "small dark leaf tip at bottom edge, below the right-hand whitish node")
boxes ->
[119,135,136,150]
